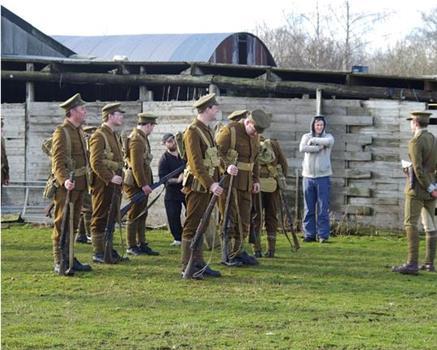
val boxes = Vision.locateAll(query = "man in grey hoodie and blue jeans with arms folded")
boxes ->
[299,115,334,243]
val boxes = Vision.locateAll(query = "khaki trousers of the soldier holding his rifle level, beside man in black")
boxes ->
[123,185,149,248]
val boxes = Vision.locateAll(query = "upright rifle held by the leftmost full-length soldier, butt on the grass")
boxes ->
[59,172,74,276]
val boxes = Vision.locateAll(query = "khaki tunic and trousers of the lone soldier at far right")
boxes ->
[404,129,437,265]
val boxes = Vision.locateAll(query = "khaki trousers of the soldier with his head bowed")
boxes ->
[219,188,252,257]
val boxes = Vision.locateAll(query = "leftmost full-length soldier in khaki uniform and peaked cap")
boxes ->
[51,94,91,273]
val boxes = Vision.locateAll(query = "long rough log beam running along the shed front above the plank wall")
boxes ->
[1,70,437,101]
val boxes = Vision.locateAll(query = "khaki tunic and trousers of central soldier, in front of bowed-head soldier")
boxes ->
[182,119,219,270]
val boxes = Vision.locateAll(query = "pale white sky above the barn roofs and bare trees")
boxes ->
[1,0,437,46]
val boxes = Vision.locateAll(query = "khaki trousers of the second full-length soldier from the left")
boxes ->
[91,182,121,254]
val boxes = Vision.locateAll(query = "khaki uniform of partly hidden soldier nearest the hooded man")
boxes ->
[251,137,288,251]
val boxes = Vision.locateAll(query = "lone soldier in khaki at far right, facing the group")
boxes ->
[392,112,437,275]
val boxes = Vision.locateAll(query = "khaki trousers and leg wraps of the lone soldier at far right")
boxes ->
[404,195,436,264]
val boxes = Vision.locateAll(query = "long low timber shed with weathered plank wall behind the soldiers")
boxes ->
[1,6,437,229]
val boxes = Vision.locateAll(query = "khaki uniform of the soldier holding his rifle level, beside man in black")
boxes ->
[123,128,153,248]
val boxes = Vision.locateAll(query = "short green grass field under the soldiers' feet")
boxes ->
[2,226,437,350]
